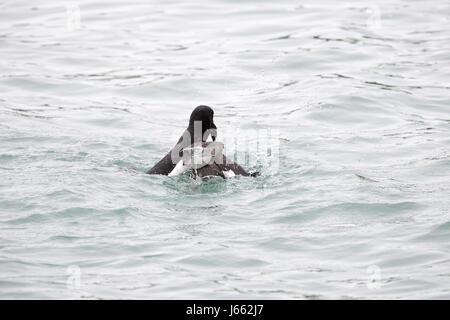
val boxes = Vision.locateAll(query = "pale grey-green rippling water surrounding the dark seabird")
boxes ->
[0,0,450,299]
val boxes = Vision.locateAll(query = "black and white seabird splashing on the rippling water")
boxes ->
[147,106,257,178]
